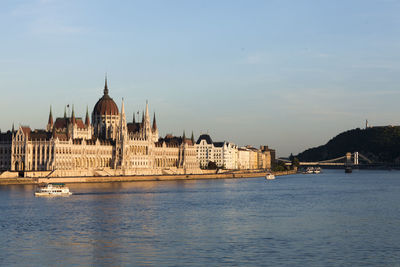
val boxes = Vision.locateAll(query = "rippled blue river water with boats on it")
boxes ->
[0,171,400,266]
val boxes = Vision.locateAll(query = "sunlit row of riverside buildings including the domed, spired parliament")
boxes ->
[0,78,274,177]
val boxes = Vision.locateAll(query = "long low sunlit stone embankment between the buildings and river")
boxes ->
[0,170,297,186]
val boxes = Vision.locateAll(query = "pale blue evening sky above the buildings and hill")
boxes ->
[0,0,400,156]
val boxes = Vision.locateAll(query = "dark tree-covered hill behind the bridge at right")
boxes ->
[297,126,400,163]
